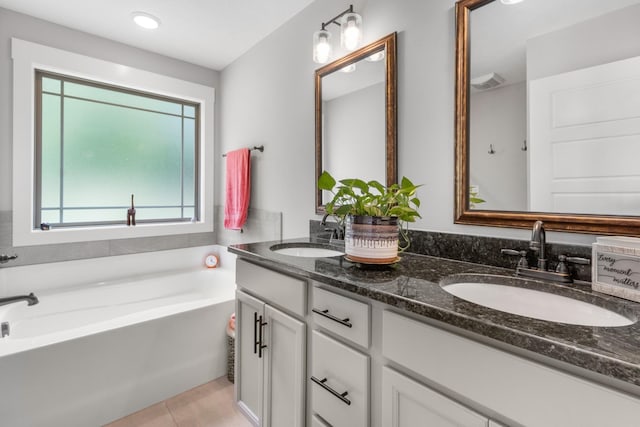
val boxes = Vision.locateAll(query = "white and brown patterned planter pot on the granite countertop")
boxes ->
[344,215,400,264]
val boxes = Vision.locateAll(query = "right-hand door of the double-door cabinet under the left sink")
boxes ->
[262,305,306,427]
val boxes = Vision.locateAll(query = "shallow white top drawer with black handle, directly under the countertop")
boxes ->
[313,287,370,348]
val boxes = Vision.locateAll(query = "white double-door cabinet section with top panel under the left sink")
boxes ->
[235,260,306,427]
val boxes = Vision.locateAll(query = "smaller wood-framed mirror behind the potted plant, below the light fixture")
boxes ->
[315,33,398,214]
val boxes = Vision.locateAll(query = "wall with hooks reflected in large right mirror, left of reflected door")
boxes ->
[469,82,528,211]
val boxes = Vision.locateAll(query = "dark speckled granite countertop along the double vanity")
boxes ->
[229,238,640,390]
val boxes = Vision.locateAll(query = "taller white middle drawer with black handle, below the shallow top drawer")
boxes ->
[309,331,369,427]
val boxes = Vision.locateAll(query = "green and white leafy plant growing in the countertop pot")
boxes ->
[318,171,422,251]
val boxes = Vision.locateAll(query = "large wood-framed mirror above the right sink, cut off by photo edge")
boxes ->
[455,0,640,235]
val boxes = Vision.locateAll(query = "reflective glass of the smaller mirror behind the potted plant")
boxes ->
[322,58,386,203]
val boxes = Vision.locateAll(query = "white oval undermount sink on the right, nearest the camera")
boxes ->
[441,279,637,327]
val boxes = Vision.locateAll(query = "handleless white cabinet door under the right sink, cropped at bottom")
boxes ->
[382,366,489,427]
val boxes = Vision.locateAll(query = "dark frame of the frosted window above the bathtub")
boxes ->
[33,69,201,228]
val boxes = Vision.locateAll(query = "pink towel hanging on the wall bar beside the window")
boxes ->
[224,148,251,230]
